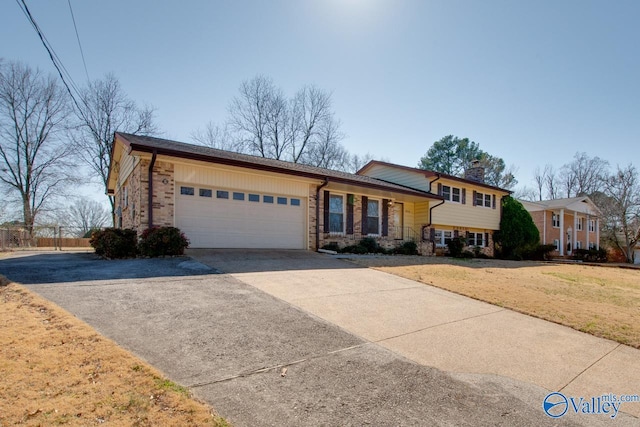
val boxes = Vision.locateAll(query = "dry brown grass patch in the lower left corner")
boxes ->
[0,276,228,426]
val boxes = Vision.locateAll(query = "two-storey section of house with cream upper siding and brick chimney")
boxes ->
[358,160,511,255]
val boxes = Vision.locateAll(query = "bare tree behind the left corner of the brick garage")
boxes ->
[73,74,158,221]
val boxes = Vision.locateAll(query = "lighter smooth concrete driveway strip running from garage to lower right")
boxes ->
[189,250,640,417]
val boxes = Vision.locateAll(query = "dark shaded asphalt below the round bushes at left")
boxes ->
[0,252,219,285]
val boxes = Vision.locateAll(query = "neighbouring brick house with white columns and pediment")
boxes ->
[520,196,602,256]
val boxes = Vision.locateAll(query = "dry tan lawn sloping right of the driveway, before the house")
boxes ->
[351,257,640,348]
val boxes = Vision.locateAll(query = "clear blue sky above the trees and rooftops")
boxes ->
[0,0,640,194]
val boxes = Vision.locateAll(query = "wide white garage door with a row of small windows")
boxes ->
[175,184,307,249]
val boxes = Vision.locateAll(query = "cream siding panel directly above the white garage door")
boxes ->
[175,164,309,198]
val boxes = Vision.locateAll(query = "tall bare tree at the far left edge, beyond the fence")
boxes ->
[0,62,73,237]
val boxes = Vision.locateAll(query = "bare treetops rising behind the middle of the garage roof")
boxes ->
[229,76,346,167]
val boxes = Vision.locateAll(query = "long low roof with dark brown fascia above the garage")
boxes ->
[110,132,441,200]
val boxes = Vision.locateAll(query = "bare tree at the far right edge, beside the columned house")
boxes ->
[600,164,640,263]
